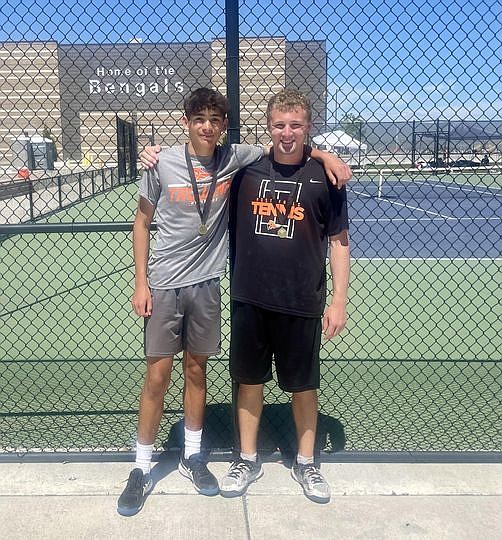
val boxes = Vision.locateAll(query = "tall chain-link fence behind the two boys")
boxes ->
[0,0,502,456]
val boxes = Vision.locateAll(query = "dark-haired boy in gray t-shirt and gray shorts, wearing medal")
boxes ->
[117,88,350,516]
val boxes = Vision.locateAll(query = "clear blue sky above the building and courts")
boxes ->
[0,0,502,120]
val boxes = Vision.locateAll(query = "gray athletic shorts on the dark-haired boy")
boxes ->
[145,278,221,358]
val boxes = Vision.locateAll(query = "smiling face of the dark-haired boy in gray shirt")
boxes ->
[182,109,227,156]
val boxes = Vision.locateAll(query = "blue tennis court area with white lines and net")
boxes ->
[348,170,502,259]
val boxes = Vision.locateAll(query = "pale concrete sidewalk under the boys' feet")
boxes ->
[0,459,502,540]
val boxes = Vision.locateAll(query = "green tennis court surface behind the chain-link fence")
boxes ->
[0,185,502,452]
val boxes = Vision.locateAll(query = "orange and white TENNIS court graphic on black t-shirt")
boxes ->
[251,179,305,238]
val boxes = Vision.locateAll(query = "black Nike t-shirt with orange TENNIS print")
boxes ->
[230,156,348,317]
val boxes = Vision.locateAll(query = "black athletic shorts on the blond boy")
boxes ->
[230,300,322,392]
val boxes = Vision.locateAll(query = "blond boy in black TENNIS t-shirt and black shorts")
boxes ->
[220,90,350,502]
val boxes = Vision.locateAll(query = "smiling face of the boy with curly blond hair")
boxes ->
[267,107,311,164]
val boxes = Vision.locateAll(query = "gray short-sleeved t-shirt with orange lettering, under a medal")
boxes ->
[139,144,264,289]
